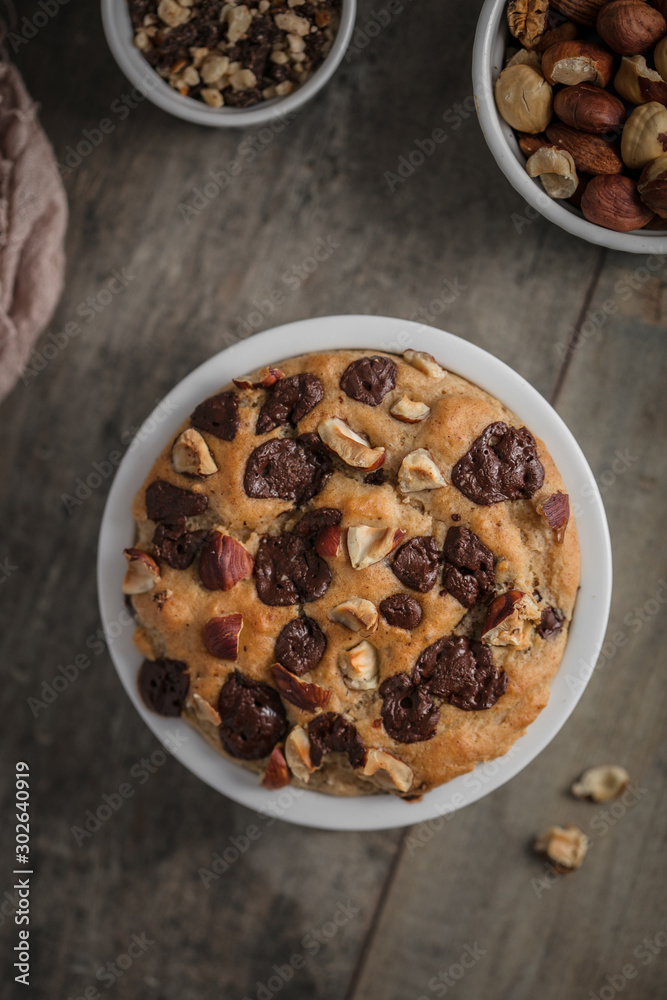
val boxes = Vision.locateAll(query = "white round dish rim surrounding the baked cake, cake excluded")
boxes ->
[97,316,611,830]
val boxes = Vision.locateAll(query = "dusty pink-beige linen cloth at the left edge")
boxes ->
[0,62,67,400]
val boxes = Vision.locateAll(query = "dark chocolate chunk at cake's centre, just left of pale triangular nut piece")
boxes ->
[255,532,331,607]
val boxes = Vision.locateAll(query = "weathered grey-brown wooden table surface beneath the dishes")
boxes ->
[0,0,667,1000]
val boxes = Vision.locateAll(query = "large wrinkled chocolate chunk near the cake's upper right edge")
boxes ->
[452,421,544,507]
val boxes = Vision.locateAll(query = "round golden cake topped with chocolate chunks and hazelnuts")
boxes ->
[124,351,579,799]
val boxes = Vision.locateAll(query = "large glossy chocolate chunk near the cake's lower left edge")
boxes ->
[218,670,287,760]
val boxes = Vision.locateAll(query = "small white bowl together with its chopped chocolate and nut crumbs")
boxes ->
[102,0,356,129]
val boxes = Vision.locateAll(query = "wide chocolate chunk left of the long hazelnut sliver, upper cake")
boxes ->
[243,434,333,504]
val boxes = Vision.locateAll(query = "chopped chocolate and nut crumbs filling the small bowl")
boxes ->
[128,0,341,108]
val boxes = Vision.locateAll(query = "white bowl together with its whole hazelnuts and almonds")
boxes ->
[473,0,667,254]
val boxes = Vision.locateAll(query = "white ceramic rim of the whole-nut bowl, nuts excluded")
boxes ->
[472,0,667,254]
